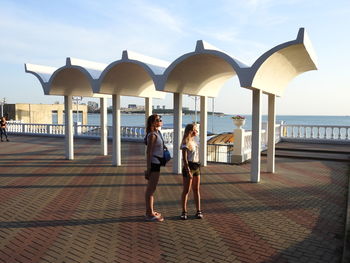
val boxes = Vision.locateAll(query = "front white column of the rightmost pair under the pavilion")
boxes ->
[250,89,261,183]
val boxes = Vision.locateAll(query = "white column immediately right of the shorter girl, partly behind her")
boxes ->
[199,96,208,166]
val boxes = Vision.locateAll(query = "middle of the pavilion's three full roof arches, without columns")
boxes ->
[95,50,168,98]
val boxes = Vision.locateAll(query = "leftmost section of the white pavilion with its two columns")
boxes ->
[25,58,110,160]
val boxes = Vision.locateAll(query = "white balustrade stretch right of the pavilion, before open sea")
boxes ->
[281,124,350,144]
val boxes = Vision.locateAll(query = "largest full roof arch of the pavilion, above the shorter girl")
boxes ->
[158,40,247,97]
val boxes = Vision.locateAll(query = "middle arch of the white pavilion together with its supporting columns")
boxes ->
[94,51,169,166]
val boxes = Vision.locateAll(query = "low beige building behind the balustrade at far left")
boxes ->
[4,103,87,125]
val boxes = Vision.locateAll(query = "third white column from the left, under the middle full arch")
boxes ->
[112,94,121,166]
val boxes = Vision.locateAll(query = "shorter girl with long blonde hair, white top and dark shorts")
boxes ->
[181,124,203,220]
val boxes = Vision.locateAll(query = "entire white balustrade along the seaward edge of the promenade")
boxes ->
[7,121,350,165]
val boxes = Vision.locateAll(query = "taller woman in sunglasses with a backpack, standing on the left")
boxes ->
[145,114,164,222]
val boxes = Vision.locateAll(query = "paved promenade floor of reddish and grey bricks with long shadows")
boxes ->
[0,136,349,263]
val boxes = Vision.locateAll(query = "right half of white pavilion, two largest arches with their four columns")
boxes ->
[158,28,317,182]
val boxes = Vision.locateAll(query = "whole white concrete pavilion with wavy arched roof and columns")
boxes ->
[26,28,317,182]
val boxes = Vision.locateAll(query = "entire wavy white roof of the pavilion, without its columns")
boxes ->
[25,28,317,98]
